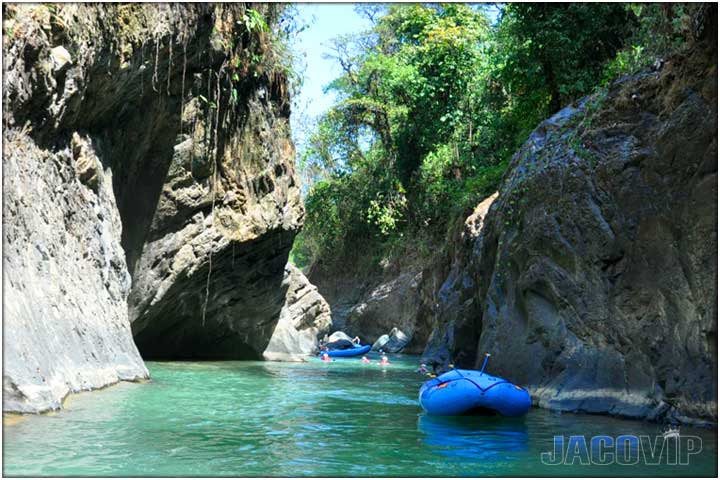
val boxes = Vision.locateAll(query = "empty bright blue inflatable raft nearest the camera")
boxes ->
[420,369,532,417]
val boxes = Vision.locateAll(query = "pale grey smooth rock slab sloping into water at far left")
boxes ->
[3,131,148,413]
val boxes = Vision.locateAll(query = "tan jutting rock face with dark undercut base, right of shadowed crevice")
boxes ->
[127,79,303,359]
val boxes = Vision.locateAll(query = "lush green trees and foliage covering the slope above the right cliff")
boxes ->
[292,3,691,267]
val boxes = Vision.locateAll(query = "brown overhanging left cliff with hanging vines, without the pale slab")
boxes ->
[6,4,312,359]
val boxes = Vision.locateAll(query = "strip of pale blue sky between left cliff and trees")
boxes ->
[290,3,370,146]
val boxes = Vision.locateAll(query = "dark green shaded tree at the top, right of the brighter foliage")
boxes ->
[493,3,636,125]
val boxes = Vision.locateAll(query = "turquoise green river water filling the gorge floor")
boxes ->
[3,356,717,476]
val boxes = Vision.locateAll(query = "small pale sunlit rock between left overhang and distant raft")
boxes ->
[263,264,332,361]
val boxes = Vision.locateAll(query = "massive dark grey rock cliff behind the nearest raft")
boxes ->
[424,41,717,423]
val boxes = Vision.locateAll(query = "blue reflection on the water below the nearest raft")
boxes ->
[418,414,529,460]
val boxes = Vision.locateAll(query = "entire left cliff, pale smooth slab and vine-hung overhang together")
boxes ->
[3,4,322,411]
